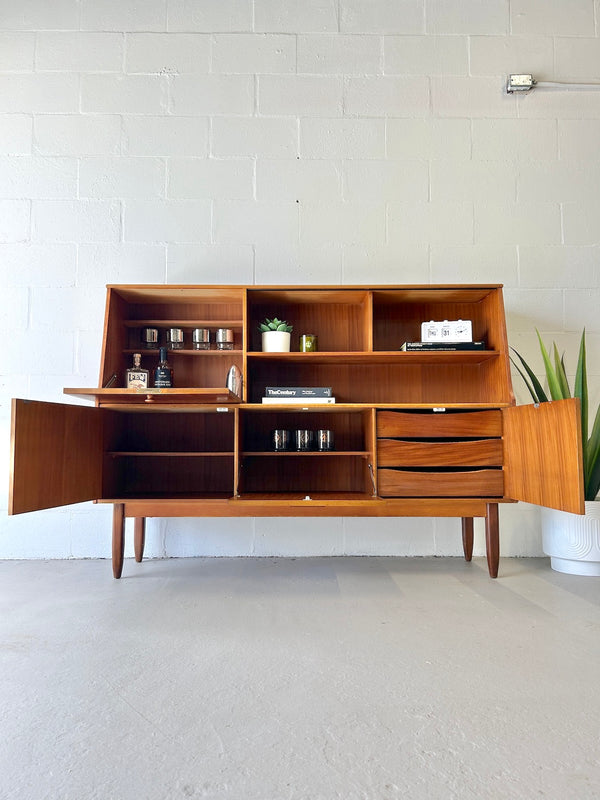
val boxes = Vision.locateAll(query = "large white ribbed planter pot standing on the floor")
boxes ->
[542,500,600,575]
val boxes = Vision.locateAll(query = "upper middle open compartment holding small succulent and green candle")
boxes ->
[248,289,371,352]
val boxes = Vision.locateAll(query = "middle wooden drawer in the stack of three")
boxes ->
[377,439,502,467]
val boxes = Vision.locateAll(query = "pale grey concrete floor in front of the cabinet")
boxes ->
[0,558,600,800]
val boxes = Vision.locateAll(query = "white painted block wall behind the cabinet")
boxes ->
[0,0,600,558]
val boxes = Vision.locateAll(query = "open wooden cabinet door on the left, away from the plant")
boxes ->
[8,400,103,514]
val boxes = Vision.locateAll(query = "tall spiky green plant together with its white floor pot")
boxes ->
[511,330,600,575]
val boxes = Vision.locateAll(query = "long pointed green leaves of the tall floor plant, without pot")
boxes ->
[511,328,600,500]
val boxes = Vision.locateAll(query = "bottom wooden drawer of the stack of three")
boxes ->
[377,469,504,497]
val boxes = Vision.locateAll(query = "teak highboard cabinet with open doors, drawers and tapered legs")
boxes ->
[9,285,584,578]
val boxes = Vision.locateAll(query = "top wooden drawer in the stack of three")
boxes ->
[377,409,502,438]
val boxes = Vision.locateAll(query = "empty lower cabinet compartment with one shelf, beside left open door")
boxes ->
[103,410,235,498]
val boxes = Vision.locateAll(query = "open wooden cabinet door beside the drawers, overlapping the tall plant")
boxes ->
[502,398,585,514]
